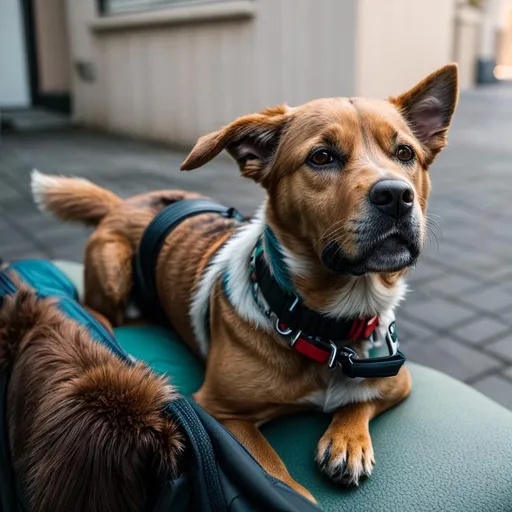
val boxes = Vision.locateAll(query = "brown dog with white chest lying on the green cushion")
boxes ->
[33,65,458,499]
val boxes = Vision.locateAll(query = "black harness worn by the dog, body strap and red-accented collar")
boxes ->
[135,198,405,378]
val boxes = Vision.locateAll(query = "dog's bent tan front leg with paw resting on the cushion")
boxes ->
[316,366,411,485]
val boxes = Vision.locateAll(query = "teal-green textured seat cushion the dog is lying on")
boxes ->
[116,327,512,512]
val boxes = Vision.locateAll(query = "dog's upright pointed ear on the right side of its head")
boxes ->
[390,64,459,158]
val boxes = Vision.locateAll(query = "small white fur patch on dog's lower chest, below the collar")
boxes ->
[299,369,380,412]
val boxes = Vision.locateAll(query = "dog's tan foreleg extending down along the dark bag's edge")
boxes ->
[222,420,316,503]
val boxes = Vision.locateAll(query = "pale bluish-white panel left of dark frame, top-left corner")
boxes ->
[0,0,30,107]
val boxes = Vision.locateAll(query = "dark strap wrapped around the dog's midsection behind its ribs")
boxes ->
[134,198,243,323]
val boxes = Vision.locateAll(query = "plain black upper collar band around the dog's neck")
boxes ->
[256,254,360,341]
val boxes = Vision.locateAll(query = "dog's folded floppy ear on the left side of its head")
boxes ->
[181,105,289,182]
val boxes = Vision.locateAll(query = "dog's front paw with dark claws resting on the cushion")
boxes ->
[316,430,375,485]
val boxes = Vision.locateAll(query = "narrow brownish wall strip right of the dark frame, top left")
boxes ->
[33,0,71,93]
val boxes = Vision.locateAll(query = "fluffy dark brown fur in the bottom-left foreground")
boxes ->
[0,276,183,512]
